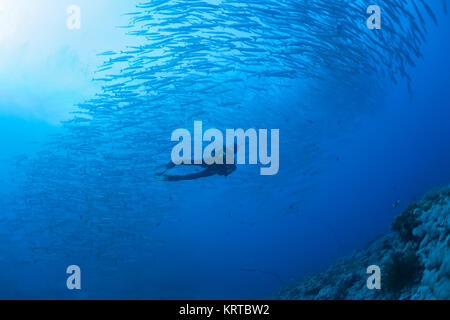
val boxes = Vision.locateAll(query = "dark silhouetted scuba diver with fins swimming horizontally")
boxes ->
[156,143,238,181]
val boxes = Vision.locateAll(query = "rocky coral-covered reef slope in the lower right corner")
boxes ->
[276,186,450,300]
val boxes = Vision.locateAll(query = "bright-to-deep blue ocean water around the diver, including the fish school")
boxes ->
[0,0,450,299]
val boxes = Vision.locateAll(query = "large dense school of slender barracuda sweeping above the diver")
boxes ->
[1,0,447,264]
